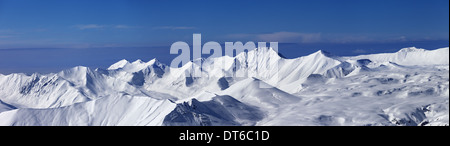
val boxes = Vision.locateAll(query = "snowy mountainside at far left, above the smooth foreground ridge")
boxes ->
[0,74,89,108]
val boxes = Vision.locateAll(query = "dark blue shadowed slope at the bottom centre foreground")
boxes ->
[164,95,265,126]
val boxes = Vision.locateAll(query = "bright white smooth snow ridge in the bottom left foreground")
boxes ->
[0,96,176,126]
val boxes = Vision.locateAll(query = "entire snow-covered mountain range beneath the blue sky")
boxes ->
[0,47,449,126]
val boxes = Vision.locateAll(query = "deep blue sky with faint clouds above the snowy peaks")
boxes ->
[0,0,449,73]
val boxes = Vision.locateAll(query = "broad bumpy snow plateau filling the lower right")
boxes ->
[259,66,449,125]
